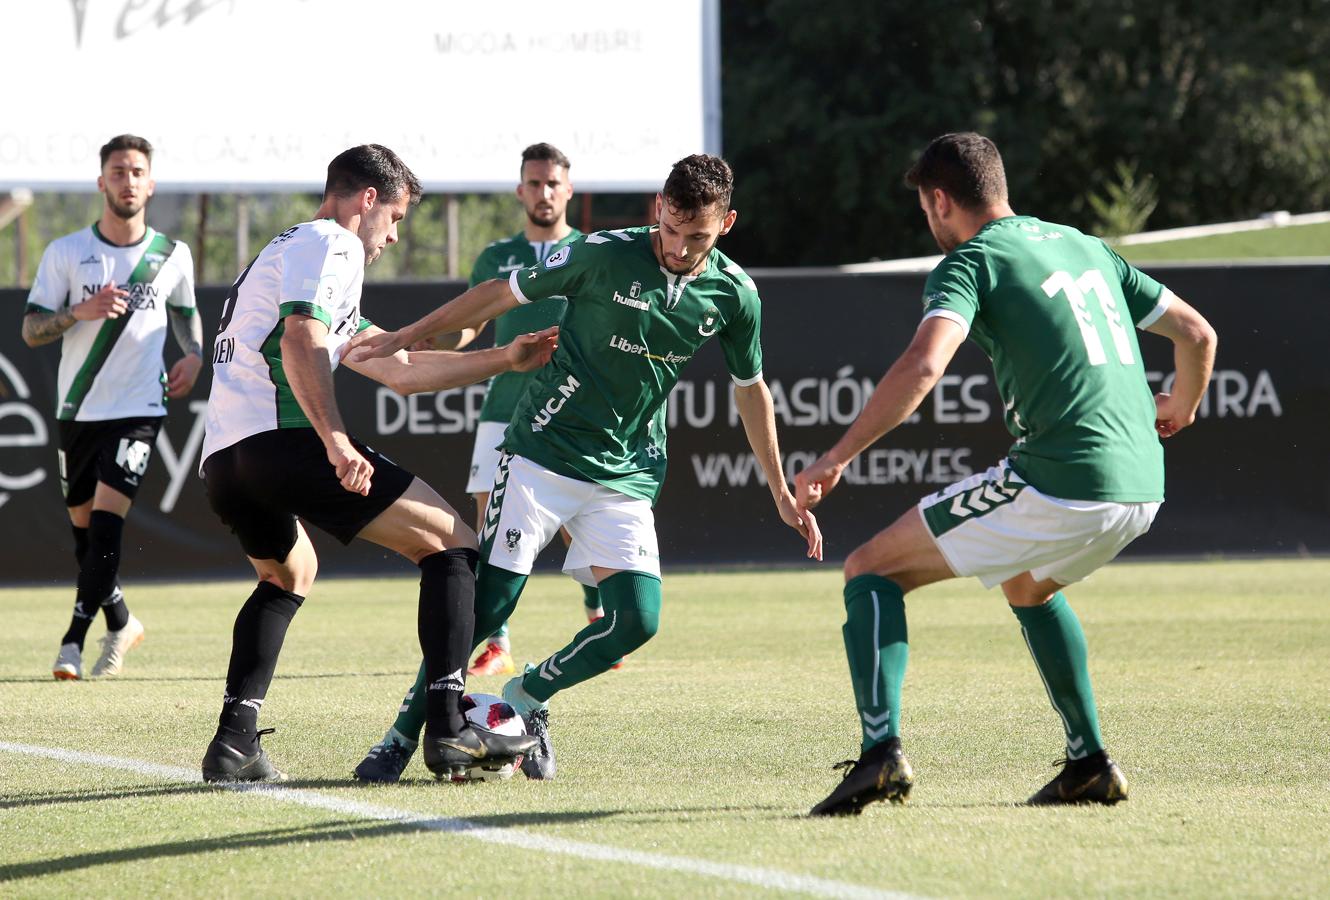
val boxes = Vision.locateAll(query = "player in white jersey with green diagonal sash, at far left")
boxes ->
[23,134,203,681]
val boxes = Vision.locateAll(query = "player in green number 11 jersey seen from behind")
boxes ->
[795,133,1216,815]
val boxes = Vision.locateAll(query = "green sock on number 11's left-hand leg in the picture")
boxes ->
[841,576,910,750]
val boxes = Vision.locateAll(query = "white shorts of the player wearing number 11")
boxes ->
[919,460,1161,588]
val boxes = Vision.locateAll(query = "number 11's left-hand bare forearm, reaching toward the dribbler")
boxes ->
[794,316,966,509]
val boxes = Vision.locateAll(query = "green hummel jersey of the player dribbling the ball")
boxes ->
[503,227,762,503]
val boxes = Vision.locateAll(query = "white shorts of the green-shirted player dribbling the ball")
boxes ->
[480,453,661,586]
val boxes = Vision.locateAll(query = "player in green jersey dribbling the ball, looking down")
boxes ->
[348,154,822,779]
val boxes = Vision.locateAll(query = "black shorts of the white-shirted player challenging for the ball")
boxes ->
[203,428,415,561]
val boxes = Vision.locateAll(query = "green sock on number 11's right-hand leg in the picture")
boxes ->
[1011,592,1104,760]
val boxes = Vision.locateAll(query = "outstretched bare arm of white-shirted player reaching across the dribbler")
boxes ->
[344,326,559,395]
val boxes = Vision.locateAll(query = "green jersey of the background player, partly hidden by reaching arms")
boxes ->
[471,229,581,423]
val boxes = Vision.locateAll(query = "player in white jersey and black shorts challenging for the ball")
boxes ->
[201,144,557,782]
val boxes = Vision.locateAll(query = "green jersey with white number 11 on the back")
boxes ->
[923,215,1172,503]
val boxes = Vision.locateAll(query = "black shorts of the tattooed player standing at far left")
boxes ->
[60,416,162,506]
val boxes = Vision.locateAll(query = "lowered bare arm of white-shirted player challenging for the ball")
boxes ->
[282,315,374,496]
